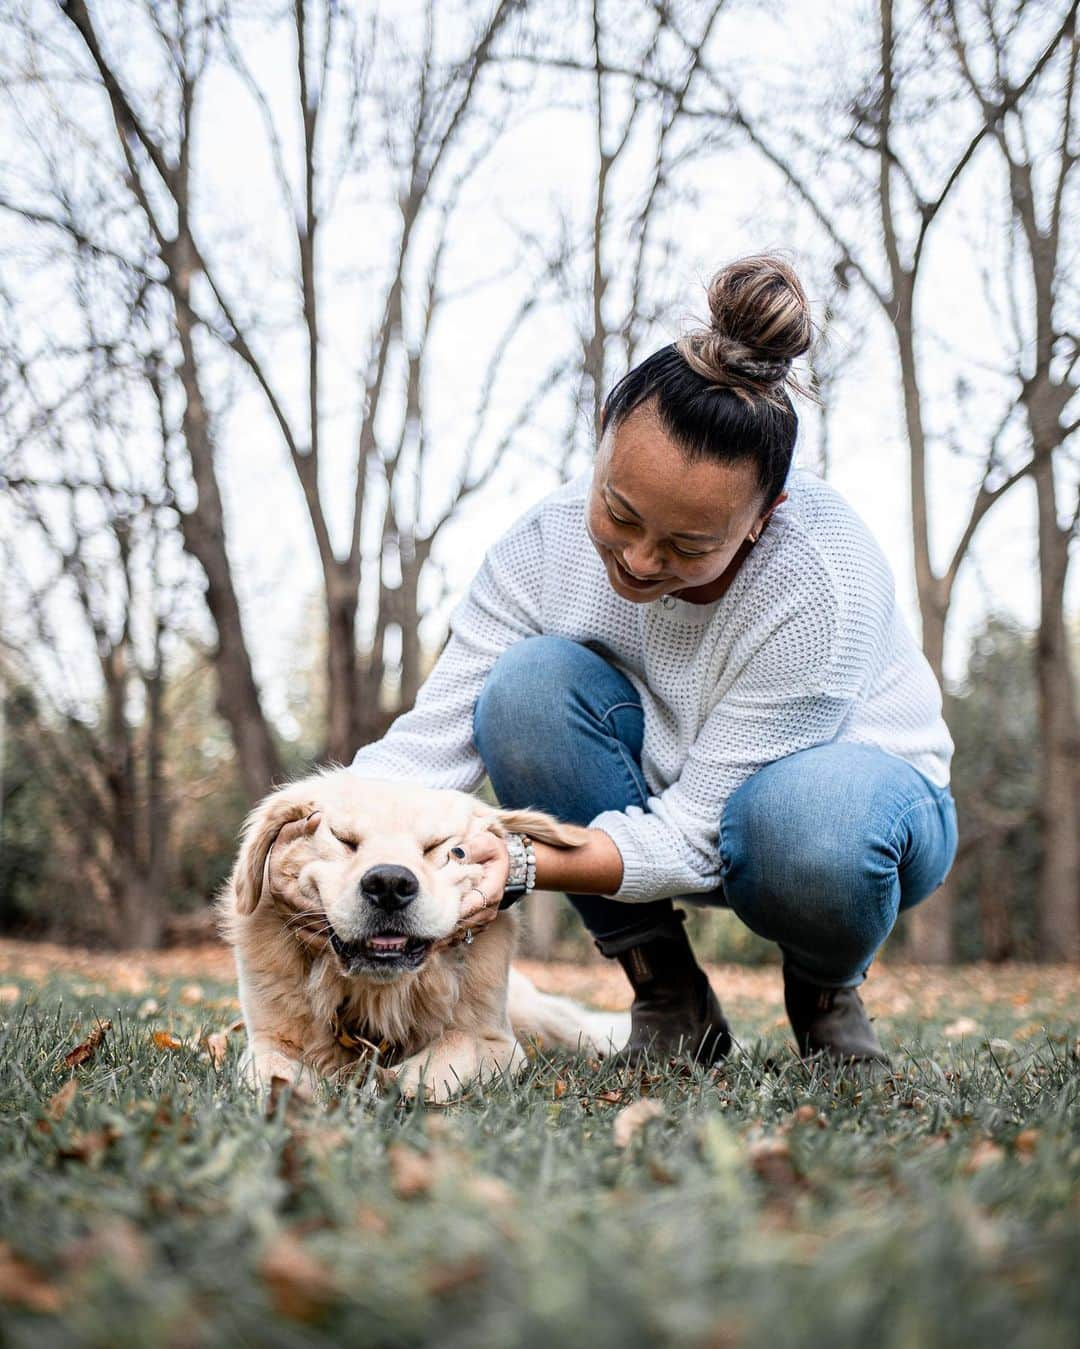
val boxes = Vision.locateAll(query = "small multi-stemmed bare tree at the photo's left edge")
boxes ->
[0,334,187,946]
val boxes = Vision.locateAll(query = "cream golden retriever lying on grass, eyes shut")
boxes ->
[218,769,628,1099]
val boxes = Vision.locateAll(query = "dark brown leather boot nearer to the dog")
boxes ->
[596,909,731,1067]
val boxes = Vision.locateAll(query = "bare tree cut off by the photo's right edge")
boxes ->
[934,0,1080,960]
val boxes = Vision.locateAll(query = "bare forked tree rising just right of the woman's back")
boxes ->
[660,0,1075,962]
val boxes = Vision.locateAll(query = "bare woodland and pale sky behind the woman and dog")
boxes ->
[0,0,1080,962]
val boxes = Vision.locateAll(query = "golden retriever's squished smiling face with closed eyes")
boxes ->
[261,770,485,982]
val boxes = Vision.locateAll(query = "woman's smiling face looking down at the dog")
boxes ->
[585,403,783,603]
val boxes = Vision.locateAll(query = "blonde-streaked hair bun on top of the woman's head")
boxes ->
[676,254,813,401]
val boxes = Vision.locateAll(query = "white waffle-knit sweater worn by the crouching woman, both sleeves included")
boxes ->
[353,469,952,901]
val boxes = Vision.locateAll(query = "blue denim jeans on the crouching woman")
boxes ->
[473,637,956,987]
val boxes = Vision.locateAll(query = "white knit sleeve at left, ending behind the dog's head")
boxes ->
[351,509,543,792]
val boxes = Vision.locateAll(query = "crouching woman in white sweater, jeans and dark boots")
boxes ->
[343,256,956,1062]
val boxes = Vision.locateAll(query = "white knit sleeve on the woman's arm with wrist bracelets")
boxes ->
[592,577,871,902]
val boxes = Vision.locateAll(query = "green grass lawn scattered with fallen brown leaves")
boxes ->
[0,978,1080,1349]
